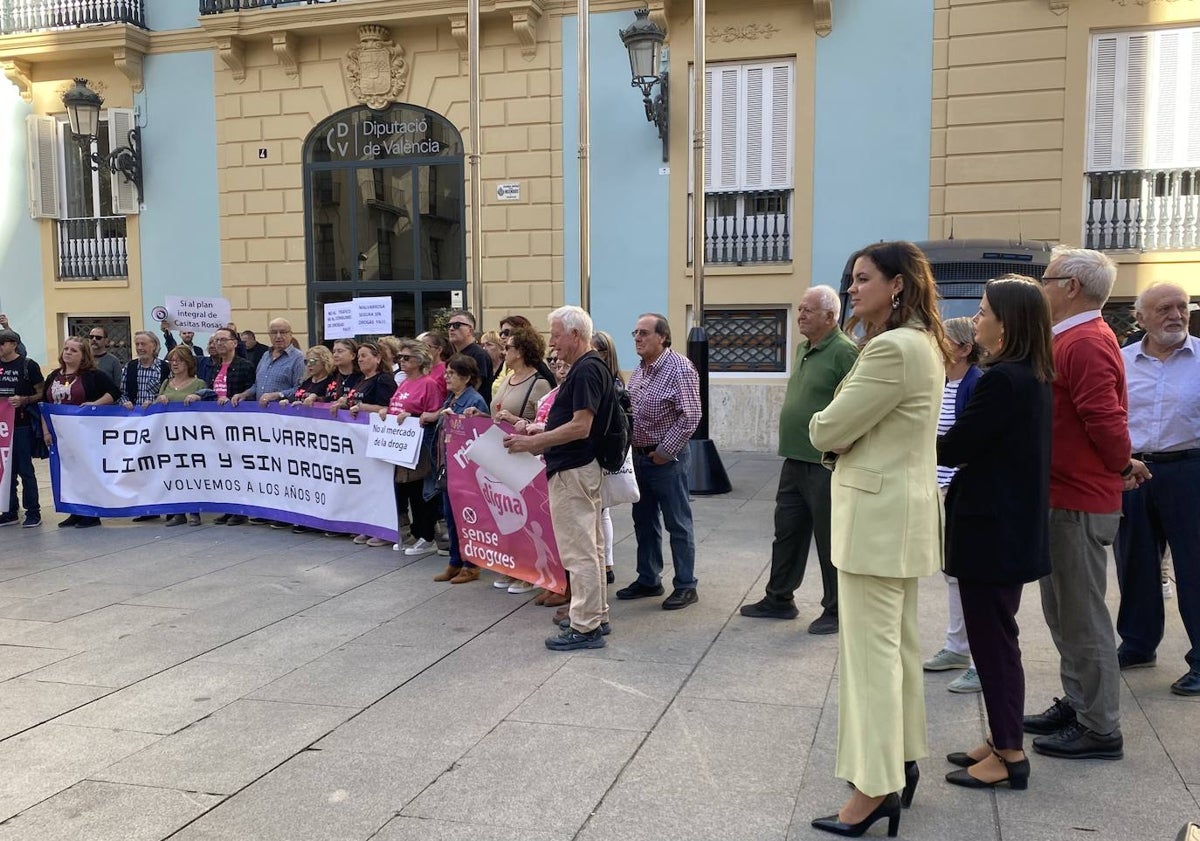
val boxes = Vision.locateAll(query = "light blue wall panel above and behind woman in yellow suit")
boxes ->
[812,0,934,288]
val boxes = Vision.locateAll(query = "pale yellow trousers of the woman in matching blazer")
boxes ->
[836,570,929,797]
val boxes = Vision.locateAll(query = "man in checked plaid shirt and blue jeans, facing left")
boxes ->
[617,313,701,611]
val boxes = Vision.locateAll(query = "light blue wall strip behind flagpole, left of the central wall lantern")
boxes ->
[563,11,667,370]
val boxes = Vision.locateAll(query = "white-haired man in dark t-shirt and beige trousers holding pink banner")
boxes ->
[504,306,613,651]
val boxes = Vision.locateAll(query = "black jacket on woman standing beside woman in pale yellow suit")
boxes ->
[937,362,1052,584]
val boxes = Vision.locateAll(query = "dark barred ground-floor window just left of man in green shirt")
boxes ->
[704,307,787,373]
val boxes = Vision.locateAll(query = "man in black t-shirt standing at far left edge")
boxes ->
[0,330,42,529]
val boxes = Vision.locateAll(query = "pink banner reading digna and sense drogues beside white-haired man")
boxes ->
[443,415,566,593]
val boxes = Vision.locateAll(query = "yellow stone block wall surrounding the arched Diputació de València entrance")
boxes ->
[214,13,563,343]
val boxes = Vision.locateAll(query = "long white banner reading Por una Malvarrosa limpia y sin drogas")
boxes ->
[43,402,397,542]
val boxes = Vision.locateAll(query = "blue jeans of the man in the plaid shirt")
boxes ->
[634,447,696,590]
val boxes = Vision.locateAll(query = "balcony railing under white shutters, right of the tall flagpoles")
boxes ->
[688,190,792,265]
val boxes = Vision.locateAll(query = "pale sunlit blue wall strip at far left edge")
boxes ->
[0,79,53,364]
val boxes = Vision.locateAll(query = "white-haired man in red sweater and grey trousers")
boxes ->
[1025,247,1146,759]
